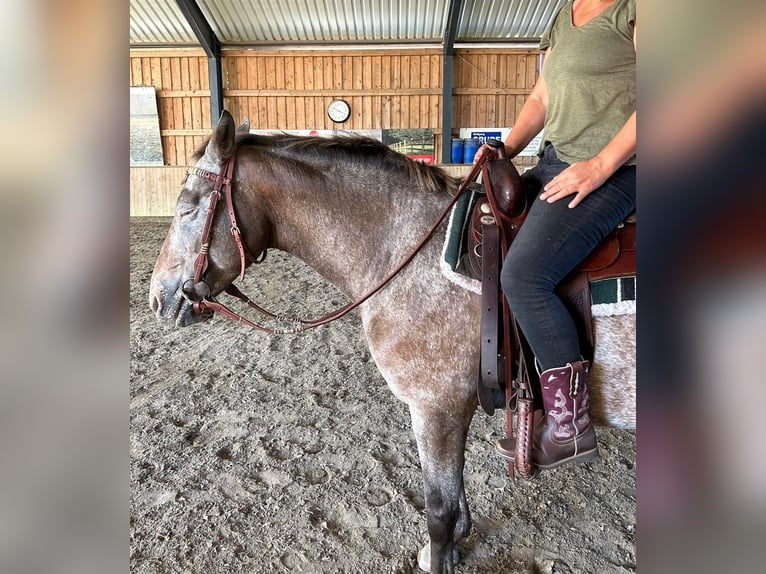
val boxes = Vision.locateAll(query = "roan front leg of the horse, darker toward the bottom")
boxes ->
[410,408,471,574]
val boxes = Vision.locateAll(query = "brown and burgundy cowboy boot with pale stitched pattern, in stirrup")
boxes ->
[496,361,598,470]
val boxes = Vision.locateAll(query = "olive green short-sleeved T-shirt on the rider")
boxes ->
[540,0,636,165]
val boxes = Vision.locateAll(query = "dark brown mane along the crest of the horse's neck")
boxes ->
[192,133,459,195]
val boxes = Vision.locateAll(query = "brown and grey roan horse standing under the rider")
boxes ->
[150,112,635,573]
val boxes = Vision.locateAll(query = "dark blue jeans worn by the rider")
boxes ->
[500,145,636,370]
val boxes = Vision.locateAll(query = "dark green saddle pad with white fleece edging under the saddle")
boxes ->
[440,196,636,317]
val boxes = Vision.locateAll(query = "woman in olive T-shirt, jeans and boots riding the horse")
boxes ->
[474,0,636,469]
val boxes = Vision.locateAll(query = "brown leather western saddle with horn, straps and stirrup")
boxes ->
[468,140,636,478]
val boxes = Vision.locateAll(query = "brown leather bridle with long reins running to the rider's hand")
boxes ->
[182,144,490,335]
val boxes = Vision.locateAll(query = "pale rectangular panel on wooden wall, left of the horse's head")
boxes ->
[130,86,164,165]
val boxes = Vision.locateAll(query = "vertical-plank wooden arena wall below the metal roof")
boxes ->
[130,48,539,214]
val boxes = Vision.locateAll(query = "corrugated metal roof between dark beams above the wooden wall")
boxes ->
[130,0,565,46]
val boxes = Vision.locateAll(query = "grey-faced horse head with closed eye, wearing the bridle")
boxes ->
[149,111,268,327]
